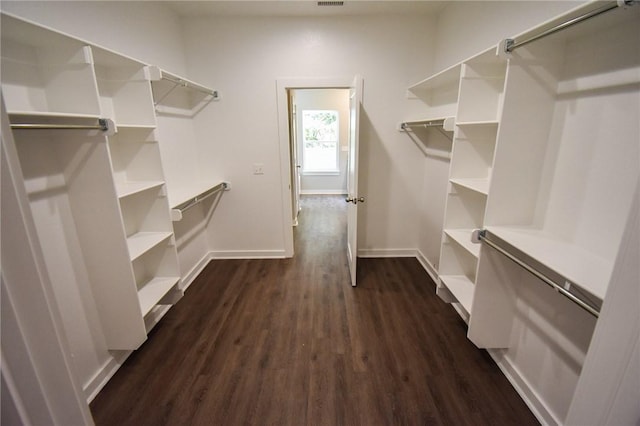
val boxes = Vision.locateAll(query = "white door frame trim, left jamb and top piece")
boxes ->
[276,76,353,257]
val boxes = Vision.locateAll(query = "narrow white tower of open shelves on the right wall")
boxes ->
[403,49,506,314]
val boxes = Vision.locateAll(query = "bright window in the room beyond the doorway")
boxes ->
[302,110,340,174]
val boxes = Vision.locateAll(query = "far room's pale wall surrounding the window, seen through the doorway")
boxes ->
[294,89,349,194]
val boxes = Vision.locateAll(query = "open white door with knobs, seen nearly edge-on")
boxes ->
[345,75,364,287]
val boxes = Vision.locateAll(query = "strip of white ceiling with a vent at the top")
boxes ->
[163,0,447,17]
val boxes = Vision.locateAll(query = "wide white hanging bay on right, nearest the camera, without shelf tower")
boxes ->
[458,3,640,424]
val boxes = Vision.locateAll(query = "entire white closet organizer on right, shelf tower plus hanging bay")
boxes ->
[411,2,640,424]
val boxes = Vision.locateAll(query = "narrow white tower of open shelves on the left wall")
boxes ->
[94,48,182,340]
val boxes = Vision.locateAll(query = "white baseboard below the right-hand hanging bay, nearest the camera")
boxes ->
[487,349,562,426]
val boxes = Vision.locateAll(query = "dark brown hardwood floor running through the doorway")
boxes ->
[91,196,538,426]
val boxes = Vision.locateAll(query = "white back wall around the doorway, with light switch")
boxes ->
[184,16,434,255]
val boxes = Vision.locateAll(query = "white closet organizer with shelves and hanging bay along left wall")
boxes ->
[2,14,182,350]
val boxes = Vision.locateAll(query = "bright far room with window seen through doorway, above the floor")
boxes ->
[288,88,349,226]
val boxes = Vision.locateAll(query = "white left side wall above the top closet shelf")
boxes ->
[0,0,186,74]
